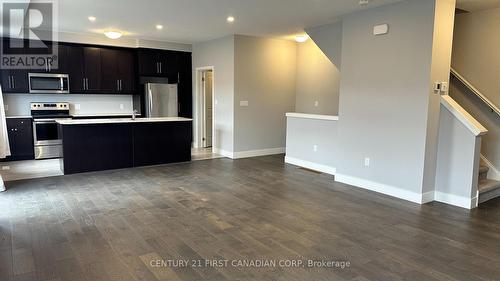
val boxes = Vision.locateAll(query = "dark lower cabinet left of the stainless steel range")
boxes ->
[5,118,35,161]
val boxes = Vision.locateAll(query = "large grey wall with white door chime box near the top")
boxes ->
[337,0,437,193]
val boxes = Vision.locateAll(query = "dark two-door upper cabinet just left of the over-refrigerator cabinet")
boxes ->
[101,48,135,94]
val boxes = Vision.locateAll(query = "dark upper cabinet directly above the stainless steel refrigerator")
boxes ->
[138,49,179,81]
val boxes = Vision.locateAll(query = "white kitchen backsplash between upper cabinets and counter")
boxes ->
[3,94,133,116]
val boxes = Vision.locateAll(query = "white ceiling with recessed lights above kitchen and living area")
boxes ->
[55,0,406,43]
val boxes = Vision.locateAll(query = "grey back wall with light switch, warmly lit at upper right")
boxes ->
[233,35,297,152]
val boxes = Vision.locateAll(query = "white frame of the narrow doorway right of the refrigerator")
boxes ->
[194,66,217,151]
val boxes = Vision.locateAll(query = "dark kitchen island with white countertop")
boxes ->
[57,117,192,174]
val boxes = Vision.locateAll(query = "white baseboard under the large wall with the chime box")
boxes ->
[335,174,430,204]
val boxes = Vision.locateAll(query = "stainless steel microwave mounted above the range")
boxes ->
[28,73,69,94]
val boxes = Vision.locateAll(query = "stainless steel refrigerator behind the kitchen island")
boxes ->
[144,83,179,117]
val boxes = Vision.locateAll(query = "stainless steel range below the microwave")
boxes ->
[31,102,71,159]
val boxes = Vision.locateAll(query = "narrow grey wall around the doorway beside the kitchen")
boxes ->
[193,36,235,152]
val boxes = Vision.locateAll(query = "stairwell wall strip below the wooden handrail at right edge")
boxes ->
[450,76,500,173]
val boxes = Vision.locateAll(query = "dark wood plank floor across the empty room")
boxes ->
[0,156,500,281]
